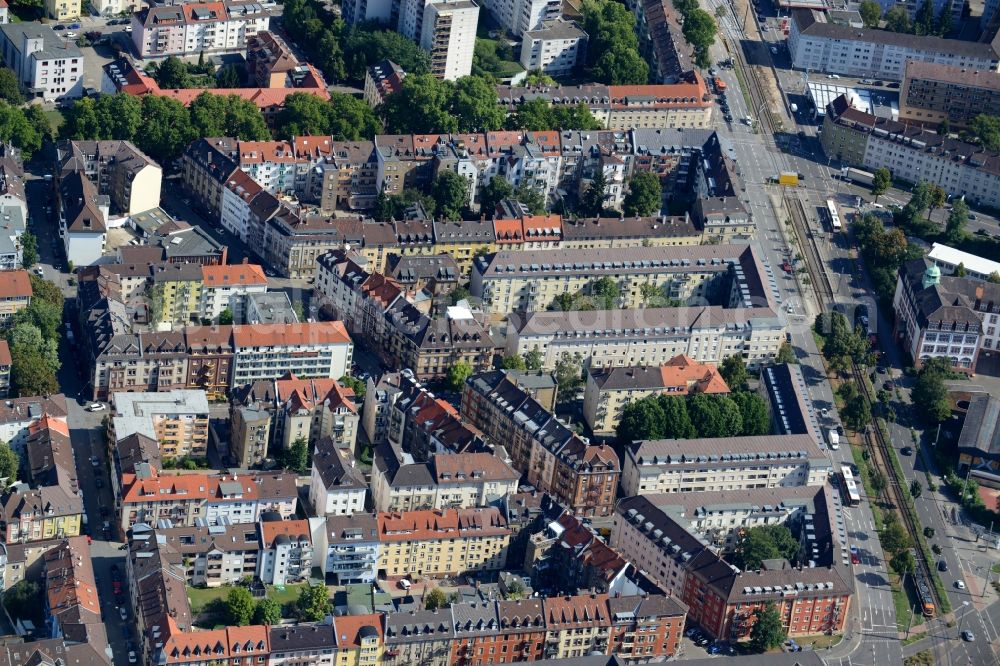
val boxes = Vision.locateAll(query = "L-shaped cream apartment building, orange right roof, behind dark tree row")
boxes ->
[583,355,729,436]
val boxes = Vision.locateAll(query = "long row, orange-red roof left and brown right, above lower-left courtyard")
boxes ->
[118,465,298,531]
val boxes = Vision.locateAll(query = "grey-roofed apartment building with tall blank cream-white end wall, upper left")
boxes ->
[56,141,163,215]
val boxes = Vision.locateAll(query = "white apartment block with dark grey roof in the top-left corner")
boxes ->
[0,22,83,102]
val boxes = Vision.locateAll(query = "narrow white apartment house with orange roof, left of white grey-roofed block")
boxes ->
[257,513,313,585]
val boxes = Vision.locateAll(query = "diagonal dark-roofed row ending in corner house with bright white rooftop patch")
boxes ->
[316,250,496,379]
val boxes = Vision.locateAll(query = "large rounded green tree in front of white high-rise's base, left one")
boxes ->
[381,74,458,134]
